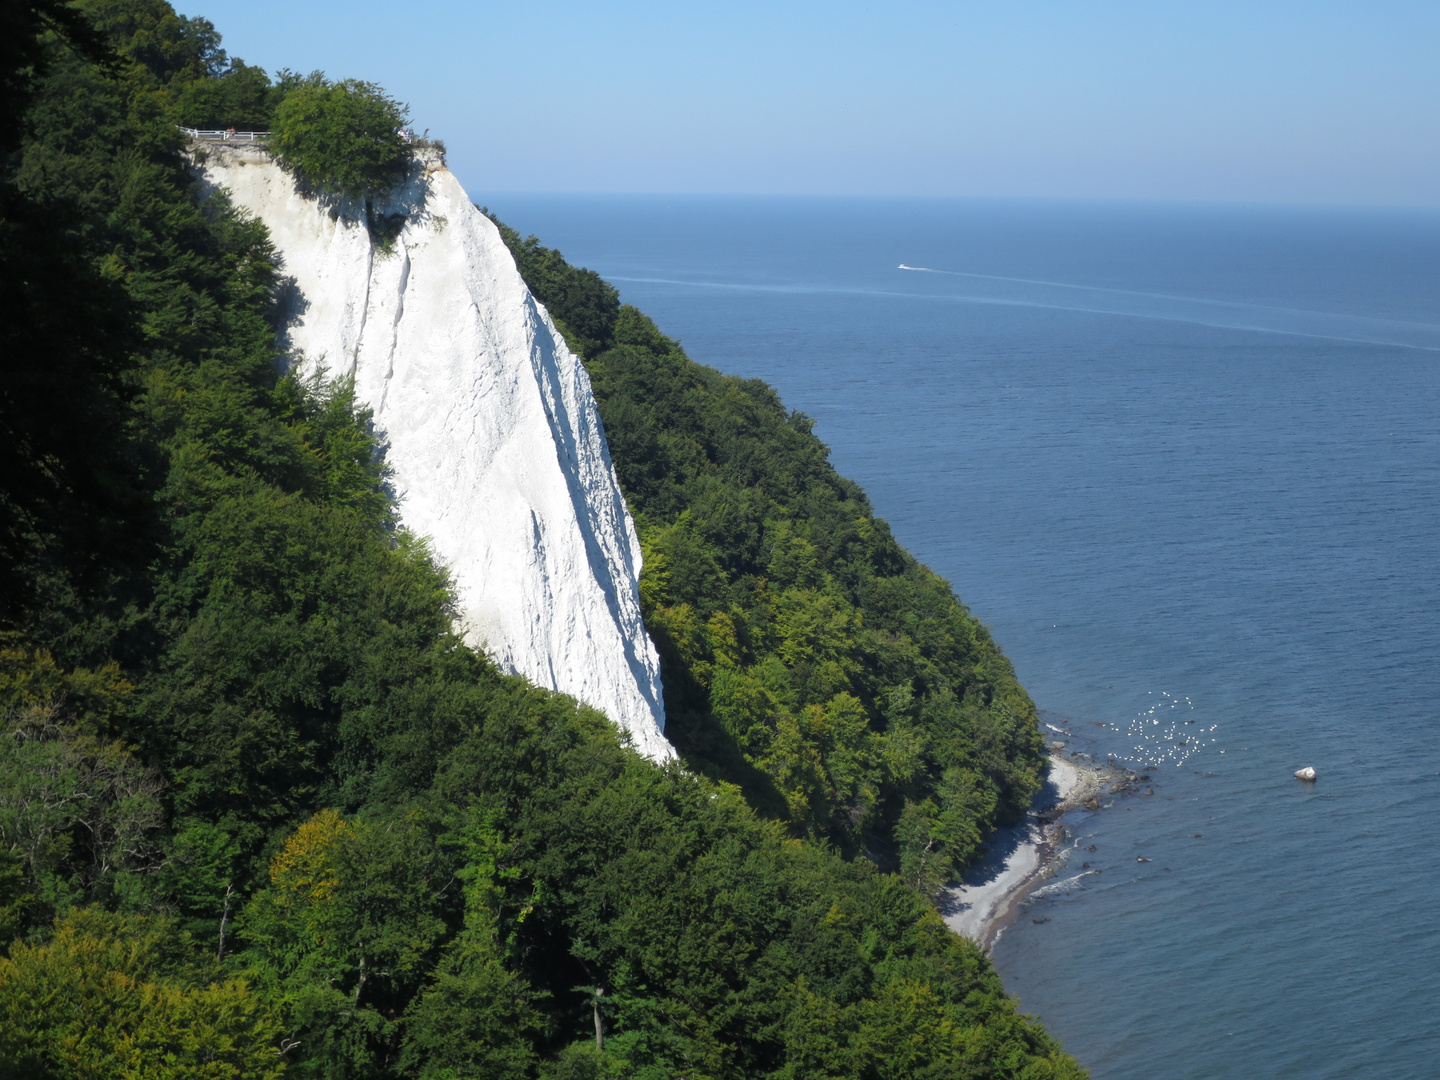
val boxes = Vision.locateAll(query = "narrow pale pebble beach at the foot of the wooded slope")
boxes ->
[939,752,1112,952]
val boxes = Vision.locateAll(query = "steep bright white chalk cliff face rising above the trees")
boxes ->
[202,147,674,760]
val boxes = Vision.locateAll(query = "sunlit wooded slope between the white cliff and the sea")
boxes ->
[503,228,1045,894]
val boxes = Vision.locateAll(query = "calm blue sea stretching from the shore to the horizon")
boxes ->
[491,196,1440,1080]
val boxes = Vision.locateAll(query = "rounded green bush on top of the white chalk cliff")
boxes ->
[271,79,409,197]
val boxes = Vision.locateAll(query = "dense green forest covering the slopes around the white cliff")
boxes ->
[0,0,1083,1080]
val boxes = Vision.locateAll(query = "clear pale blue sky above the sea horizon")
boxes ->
[180,0,1440,206]
